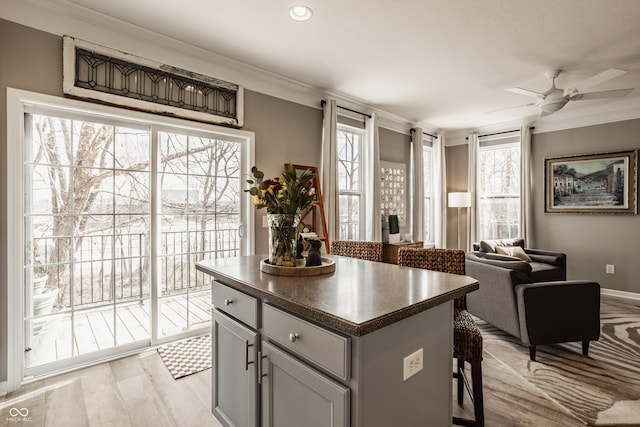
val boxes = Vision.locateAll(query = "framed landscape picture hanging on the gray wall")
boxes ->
[544,150,638,215]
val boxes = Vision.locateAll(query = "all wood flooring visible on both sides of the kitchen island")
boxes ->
[0,298,638,427]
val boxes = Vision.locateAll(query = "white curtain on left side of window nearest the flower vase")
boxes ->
[320,99,340,241]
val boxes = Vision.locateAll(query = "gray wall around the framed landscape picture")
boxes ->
[531,119,640,293]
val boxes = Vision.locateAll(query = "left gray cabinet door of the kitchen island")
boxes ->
[211,310,258,427]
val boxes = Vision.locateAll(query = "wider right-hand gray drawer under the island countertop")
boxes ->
[262,304,351,380]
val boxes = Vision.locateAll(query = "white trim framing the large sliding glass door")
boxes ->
[5,88,255,391]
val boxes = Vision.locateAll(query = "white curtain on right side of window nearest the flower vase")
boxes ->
[363,113,382,242]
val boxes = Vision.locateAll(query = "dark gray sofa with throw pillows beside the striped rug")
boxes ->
[465,239,600,360]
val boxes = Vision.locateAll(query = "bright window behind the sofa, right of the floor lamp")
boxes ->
[477,137,521,240]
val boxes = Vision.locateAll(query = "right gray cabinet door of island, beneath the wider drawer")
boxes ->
[261,341,350,427]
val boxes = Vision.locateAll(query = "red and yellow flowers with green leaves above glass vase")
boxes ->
[244,164,316,214]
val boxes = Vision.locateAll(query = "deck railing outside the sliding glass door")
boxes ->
[33,228,240,307]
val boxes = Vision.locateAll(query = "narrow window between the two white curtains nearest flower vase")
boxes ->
[338,125,364,240]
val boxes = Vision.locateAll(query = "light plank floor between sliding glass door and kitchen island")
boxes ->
[0,350,221,427]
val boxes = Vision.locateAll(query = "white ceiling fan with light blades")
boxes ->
[506,68,633,116]
